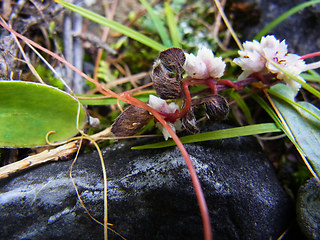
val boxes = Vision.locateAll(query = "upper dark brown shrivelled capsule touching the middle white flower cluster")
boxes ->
[159,48,186,80]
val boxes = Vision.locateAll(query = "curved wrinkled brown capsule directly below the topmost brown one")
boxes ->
[152,60,182,99]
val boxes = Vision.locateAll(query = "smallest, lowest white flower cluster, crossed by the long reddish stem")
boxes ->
[148,95,181,140]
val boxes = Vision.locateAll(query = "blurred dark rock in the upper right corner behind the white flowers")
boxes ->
[235,0,320,55]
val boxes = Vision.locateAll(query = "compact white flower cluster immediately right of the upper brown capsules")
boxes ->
[184,47,226,79]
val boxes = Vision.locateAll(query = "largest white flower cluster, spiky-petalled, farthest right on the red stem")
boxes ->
[233,35,306,90]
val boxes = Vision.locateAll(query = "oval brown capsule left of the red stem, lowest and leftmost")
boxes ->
[111,105,153,137]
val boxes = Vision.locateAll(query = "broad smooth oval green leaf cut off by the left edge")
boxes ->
[0,81,86,147]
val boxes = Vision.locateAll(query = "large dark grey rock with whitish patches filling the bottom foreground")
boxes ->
[0,125,292,240]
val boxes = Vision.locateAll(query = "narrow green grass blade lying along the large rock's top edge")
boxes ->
[132,123,281,149]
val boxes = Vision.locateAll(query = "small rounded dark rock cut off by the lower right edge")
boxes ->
[297,178,320,240]
